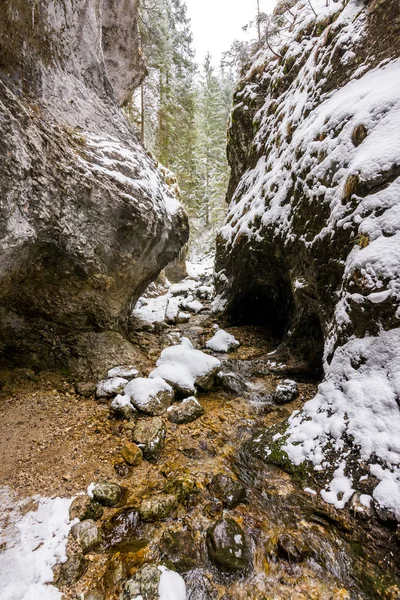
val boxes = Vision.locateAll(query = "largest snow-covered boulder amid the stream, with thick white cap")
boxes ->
[149,338,221,395]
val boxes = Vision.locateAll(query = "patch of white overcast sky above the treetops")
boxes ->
[186,0,276,65]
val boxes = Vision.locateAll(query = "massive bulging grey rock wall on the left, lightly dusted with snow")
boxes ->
[0,0,188,367]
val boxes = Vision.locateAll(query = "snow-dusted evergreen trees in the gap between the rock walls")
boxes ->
[137,0,235,235]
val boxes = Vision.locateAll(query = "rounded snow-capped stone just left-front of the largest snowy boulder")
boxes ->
[124,377,174,416]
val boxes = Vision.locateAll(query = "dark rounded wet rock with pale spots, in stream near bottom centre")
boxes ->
[207,517,251,573]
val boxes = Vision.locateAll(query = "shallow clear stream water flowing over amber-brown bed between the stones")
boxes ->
[0,268,400,600]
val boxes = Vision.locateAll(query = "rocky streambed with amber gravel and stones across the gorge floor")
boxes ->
[0,272,400,600]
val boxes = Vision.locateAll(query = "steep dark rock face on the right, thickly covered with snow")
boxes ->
[215,0,400,518]
